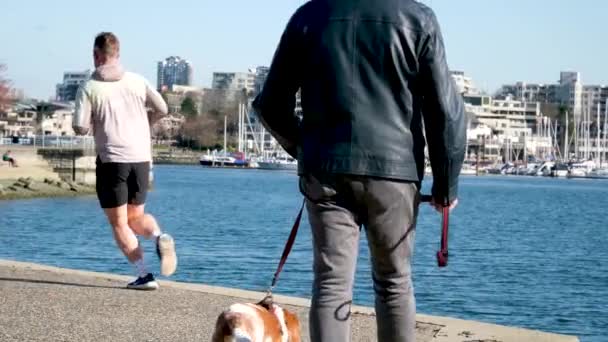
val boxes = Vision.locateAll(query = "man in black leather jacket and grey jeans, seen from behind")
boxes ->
[253,0,466,342]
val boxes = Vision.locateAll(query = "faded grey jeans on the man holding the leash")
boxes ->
[300,175,420,342]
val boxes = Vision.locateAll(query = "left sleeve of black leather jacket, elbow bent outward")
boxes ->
[253,9,302,158]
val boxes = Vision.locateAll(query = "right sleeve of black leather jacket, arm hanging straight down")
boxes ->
[420,14,466,204]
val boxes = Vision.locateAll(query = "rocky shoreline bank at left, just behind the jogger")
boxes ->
[0,178,95,200]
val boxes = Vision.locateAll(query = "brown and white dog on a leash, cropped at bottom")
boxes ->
[211,301,300,342]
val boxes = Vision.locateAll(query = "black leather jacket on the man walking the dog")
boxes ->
[253,0,466,200]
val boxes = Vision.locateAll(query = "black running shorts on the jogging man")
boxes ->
[95,157,150,209]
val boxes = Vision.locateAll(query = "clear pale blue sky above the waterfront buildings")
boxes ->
[0,0,608,98]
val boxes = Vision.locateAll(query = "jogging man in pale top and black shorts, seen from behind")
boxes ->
[73,32,177,290]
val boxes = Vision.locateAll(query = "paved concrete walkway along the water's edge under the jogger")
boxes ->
[0,260,578,342]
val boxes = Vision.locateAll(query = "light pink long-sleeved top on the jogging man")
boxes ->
[72,65,167,163]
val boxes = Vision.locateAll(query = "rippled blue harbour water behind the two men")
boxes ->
[0,166,608,342]
